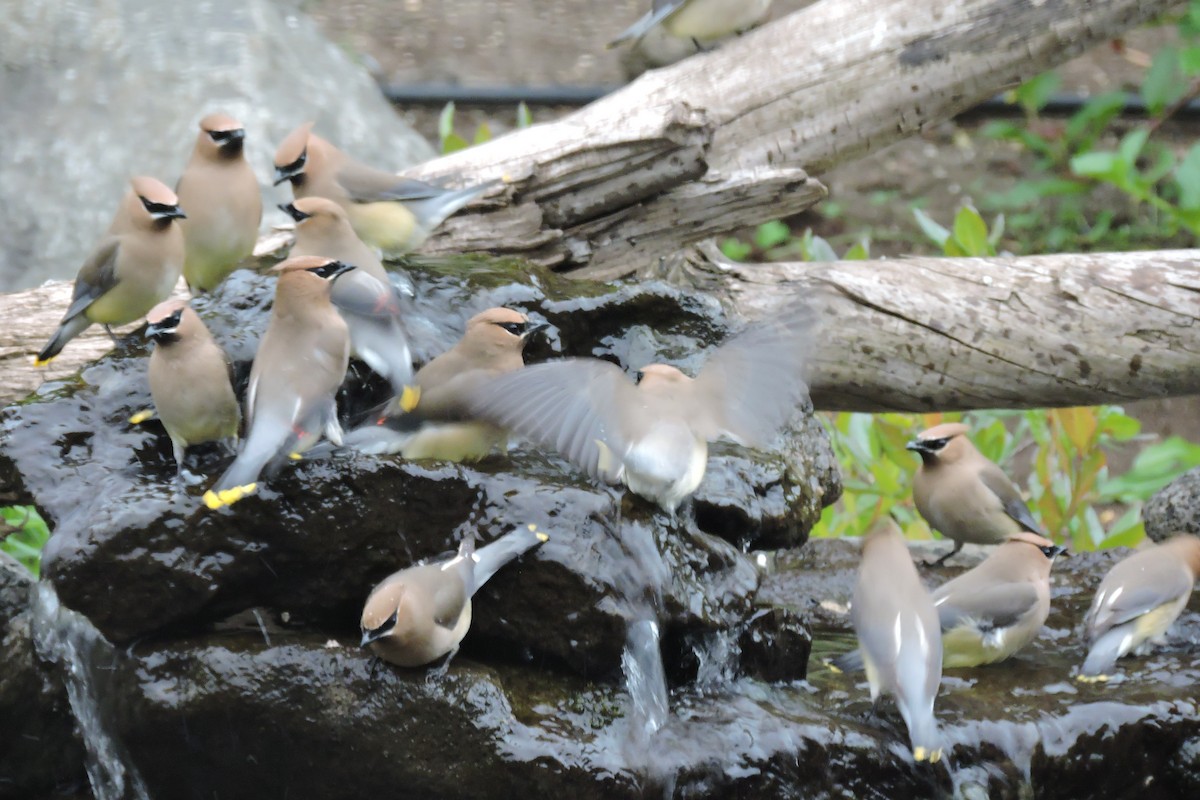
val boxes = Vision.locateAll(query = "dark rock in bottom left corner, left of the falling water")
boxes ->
[0,553,88,799]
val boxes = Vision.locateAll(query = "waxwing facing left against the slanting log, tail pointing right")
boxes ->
[275,122,500,254]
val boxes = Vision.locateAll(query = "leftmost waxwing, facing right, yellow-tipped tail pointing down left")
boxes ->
[34,176,185,367]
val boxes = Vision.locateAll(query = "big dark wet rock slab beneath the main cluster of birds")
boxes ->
[0,261,838,675]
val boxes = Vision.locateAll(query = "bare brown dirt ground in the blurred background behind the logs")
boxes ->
[301,0,1200,450]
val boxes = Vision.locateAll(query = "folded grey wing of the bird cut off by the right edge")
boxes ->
[1087,553,1192,638]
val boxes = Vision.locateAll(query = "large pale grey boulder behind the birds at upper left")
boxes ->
[0,0,434,290]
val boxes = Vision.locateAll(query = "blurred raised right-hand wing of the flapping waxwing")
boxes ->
[692,303,815,446]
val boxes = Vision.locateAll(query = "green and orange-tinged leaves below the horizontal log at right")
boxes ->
[814,405,1200,551]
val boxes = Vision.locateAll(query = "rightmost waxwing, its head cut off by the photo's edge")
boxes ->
[1079,534,1200,681]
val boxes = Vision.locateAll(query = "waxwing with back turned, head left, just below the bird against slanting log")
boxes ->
[280,197,413,395]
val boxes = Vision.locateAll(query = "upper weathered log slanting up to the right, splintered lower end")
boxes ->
[409,0,1174,278]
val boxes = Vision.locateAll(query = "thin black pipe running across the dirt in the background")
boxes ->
[382,84,1200,120]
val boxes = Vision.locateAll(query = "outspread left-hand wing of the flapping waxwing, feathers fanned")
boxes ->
[470,359,640,481]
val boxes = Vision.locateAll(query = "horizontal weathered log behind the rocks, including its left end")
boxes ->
[0,251,1200,411]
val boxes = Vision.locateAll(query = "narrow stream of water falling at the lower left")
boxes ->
[32,581,150,800]
